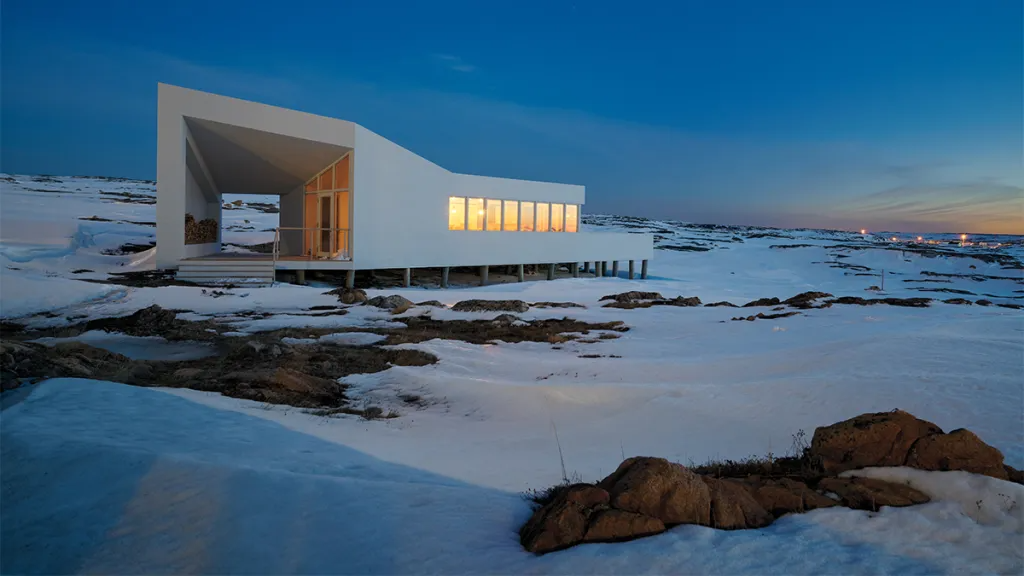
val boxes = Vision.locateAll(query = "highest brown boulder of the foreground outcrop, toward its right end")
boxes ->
[810,410,942,474]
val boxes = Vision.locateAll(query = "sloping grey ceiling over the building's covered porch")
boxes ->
[185,118,350,195]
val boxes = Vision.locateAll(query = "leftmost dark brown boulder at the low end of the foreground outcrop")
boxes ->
[519,485,608,554]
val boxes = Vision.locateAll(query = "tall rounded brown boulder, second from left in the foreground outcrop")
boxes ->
[598,457,711,526]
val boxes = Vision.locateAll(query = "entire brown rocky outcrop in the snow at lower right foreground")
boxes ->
[520,410,1011,553]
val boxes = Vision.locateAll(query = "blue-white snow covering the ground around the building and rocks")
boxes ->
[0,176,1024,574]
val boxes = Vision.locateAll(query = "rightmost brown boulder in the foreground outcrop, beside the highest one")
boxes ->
[906,428,1009,480]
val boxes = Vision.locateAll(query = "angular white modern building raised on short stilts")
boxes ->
[157,84,653,282]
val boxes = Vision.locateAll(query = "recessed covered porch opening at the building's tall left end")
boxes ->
[183,117,352,260]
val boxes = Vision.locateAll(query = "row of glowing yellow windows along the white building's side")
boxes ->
[449,196,580,232]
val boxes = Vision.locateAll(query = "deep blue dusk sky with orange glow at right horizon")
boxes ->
[0,0,1024,233]
